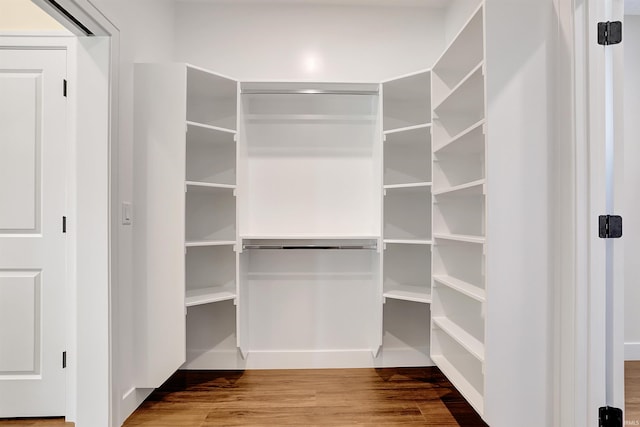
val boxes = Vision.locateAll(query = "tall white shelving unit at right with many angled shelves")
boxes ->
[431,5,490,415]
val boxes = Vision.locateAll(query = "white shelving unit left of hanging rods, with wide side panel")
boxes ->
[134,64,238,388]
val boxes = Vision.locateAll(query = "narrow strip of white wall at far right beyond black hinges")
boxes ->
[623,16,640,360]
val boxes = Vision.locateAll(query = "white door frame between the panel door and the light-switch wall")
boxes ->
[0,0,120,427]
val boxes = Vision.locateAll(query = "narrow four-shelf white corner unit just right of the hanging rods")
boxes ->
[382,70,432,364]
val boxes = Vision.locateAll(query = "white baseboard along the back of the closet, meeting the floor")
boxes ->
[181,348,433,369]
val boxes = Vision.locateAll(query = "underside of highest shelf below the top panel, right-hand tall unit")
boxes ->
[433,61,484,113]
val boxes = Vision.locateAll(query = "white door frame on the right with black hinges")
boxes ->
[559,0,624,427]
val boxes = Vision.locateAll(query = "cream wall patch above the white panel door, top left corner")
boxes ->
[0,0,66,32]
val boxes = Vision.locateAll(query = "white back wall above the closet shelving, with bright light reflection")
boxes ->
[175,2,444,82]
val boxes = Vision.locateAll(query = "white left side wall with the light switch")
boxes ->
[77,0,178,426]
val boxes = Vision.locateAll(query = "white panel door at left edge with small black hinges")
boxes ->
[0,49,66,417]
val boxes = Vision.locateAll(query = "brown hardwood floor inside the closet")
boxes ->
[0,368,486,427]
